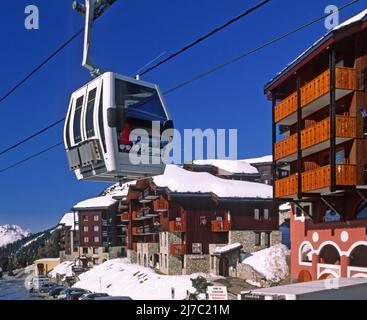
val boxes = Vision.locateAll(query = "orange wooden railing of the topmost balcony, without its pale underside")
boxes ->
[274,67,356,123]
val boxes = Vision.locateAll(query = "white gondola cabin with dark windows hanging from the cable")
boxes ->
[64,72,173,181]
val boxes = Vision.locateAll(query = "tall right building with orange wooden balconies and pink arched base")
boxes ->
[265,10,367,281]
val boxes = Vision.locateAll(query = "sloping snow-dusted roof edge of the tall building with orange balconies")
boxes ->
[265,9,367,91]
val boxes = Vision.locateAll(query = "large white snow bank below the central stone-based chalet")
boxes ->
[74,259,193,300]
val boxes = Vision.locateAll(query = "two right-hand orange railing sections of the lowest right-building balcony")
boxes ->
[302,164,357,192]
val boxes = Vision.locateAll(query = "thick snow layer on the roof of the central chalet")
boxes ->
[153,165,273,199]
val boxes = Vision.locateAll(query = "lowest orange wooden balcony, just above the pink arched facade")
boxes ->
[275,164,357,198]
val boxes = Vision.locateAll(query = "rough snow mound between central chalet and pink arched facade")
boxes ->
[242,244,291,283]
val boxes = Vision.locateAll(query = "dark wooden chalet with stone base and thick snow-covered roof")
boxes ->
[120,165,281,276]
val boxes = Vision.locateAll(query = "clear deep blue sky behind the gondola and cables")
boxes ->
[0,0,366,231]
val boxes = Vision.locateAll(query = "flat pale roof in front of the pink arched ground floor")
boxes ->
[243,278,367,295]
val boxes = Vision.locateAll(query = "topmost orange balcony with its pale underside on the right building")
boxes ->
[274,67,356,125]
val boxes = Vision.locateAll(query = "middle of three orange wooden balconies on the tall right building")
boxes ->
[274,116,357,162]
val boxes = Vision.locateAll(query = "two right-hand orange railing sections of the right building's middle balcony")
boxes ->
[301,116,356,150]
